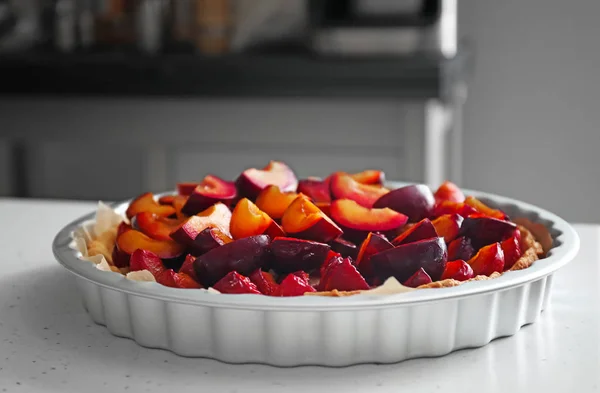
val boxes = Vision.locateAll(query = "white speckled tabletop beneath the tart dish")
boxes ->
[0,199,600,393]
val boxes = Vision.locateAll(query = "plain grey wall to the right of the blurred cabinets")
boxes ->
[460,0,600,222]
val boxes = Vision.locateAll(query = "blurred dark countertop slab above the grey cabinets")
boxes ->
[0,52,465,99]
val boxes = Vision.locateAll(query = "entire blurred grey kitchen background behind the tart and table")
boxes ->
[0,0,600,222]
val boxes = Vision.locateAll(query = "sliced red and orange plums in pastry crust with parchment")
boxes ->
[73,162,552,296]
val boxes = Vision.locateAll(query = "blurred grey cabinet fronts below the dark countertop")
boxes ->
[0,98,423,199]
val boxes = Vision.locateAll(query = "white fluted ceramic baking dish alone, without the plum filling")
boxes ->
[53,183,579,366]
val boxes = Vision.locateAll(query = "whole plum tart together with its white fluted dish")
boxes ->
[53,161,579,366]
